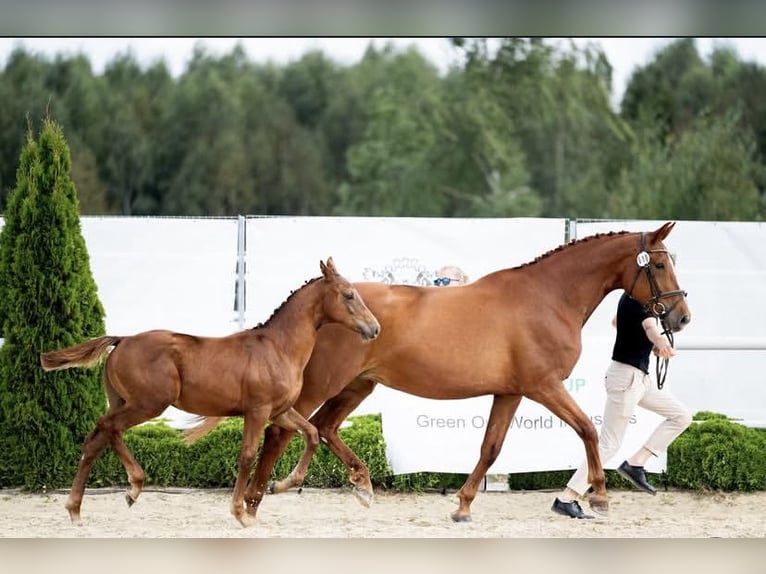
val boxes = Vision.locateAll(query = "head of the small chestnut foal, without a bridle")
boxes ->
[319,257,380,341]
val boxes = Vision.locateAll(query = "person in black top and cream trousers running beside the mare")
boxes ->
[551,293,692,518]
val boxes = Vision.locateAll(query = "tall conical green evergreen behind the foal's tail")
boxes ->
[0,118,106,490]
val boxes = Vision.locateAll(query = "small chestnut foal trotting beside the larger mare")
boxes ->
[40,258,380,526]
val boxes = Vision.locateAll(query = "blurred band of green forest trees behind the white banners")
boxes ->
[0,37,766,220]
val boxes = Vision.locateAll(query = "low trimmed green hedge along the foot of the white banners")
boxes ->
[43,412,766,491]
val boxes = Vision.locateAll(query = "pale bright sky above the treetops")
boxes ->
[0,37,766,109]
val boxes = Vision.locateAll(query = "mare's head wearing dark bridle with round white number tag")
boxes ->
[623,222,692,332]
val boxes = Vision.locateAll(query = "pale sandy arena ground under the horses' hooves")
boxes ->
[0,488,766,539]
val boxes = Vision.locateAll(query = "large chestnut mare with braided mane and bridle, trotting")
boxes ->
[190,223,691,521]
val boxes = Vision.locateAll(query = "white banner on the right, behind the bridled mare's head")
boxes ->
[576,221,766,427]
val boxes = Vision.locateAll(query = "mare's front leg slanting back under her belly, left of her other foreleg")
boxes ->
[451,395,521,522]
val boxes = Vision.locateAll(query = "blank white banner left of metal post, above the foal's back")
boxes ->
[81,217,237,336]
